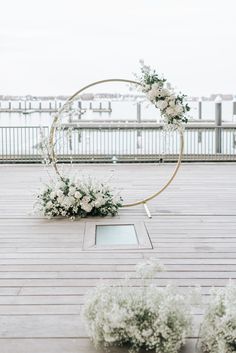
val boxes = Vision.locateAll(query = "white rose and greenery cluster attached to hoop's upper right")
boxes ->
[137,61,190,130]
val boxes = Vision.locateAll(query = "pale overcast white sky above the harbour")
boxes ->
[0,0,236,95]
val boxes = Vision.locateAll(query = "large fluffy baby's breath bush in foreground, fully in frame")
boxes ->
[84,260,191,353]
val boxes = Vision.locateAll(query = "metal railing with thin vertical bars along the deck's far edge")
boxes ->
[0,123,236,163]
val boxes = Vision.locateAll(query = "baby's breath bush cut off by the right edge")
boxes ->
[199,283,236,353]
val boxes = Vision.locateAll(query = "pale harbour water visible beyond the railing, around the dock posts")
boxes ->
[0,100,233,126]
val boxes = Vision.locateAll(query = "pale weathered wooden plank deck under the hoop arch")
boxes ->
[0,163,236,353]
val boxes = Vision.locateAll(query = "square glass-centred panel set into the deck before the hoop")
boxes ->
[83,222,152,250]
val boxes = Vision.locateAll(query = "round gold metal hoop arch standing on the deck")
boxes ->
[49,78,184,218]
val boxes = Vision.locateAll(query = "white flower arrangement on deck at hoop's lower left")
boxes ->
[35,178,122,219]
